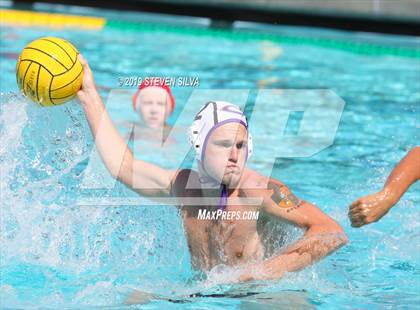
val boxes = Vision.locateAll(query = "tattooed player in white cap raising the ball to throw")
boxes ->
[78,57,347,281]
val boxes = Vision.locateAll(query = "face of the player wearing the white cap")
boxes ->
[204,123,248,187]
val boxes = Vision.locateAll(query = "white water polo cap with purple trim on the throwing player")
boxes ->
[189,101,252,162]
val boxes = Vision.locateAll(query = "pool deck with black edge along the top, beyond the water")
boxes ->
[7,0,420,36]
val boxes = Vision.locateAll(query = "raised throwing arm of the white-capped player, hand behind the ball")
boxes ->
[77,55,175,197]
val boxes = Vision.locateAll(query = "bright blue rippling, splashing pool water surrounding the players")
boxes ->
[0,9,420,309]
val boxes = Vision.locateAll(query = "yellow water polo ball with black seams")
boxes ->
[16,37,83,106]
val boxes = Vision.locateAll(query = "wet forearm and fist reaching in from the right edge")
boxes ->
[349,146,420,227]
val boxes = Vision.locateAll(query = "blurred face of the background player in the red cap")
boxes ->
[138,87,169,128]
